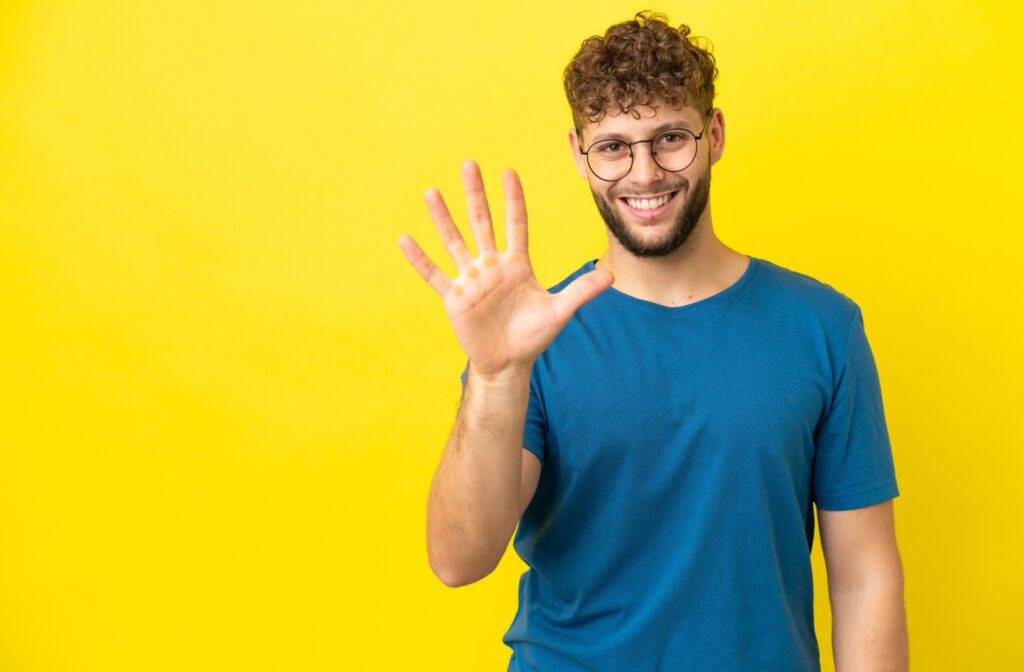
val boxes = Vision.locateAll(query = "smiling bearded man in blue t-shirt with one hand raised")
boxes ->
[399,13,907,672]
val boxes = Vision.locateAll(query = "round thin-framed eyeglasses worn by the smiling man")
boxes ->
[577,110,712,182]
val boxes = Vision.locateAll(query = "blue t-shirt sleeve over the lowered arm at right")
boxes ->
[812,306,899,510]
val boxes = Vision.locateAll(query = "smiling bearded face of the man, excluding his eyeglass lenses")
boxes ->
[572,106,717,257]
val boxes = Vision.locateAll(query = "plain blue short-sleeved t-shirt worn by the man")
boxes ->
[462,256,899,672]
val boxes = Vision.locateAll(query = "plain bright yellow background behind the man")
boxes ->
[0,0,1024,672]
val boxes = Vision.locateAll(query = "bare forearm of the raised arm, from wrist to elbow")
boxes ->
[427,366,529,586]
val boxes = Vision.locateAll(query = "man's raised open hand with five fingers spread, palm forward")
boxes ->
[398,161,614,376]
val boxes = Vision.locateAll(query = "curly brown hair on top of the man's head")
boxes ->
[563,11,718,132]
